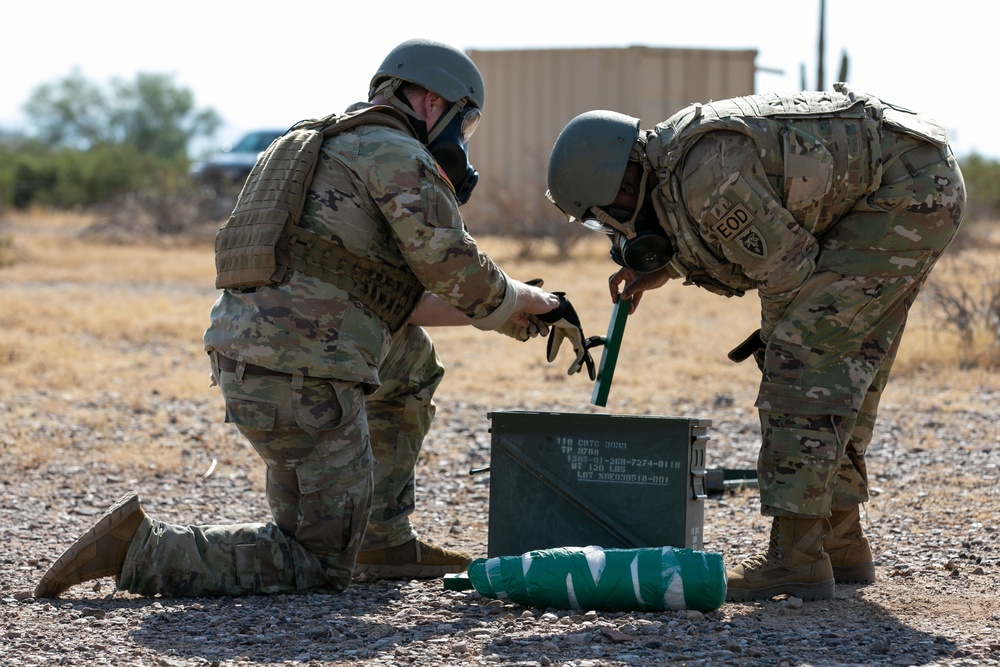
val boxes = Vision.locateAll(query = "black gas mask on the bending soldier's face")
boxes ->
[582,173,674,273]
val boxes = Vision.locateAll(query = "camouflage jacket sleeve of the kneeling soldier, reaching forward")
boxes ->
[366,131,510,320]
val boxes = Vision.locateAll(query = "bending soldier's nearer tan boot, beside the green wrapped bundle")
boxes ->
[726,517,834,602]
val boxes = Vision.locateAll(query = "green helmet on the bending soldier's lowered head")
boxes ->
[547,110,639,220]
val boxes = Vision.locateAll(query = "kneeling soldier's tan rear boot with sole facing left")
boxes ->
[35,493,146,598]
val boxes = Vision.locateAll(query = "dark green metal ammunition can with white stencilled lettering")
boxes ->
[488,411,711,557]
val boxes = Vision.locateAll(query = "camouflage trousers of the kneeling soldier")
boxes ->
[118,327,443,597]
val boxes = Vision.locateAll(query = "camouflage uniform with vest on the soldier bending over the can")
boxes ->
[646,86,965,518]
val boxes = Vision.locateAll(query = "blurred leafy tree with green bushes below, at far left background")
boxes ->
[0,70,222,208]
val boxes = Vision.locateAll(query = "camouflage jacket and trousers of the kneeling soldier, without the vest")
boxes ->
[119,107,515,595]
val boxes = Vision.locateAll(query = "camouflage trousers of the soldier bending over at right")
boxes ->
[757,157,965,517]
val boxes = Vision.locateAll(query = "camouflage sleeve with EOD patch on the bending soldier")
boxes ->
[681,132,819,340]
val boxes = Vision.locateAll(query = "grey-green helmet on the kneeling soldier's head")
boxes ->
[368,39,486,109]
